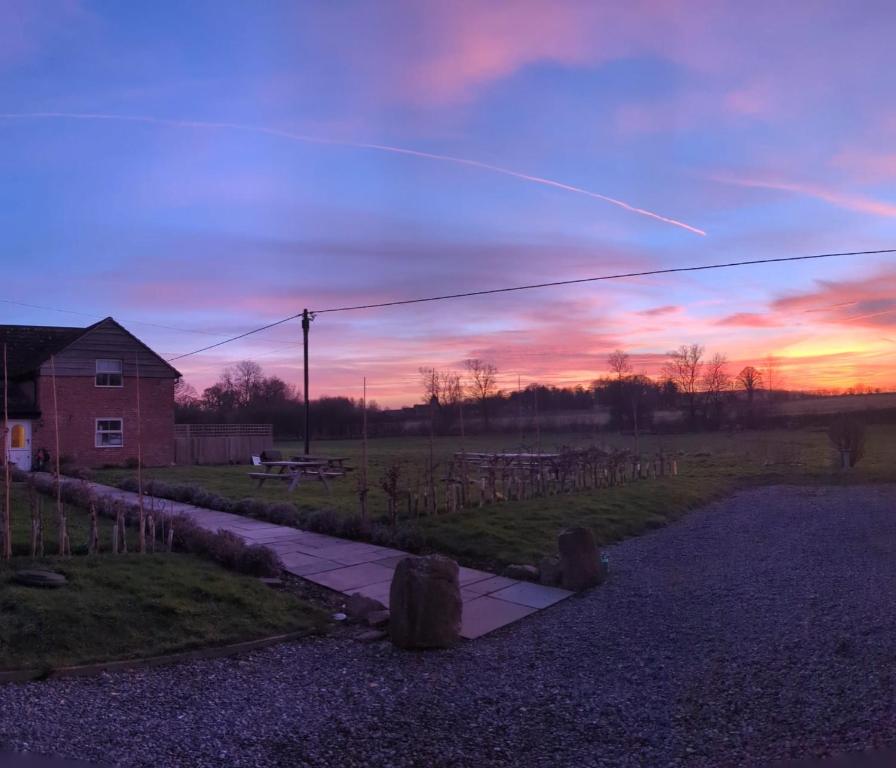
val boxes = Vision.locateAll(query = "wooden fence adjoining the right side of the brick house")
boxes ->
[174,424,274,464]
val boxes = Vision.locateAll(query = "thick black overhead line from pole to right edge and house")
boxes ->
[168,248,896,362]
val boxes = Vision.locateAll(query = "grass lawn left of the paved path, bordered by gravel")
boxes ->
[0,485,322,670]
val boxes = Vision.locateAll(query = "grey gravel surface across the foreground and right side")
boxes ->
[0,486,896,768]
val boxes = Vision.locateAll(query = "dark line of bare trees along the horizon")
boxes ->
[175,344,884,439]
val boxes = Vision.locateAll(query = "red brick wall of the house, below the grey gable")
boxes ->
[31,376,174,467]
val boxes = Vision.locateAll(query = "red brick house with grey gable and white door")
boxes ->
[0,317,180,470]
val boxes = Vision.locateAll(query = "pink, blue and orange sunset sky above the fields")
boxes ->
[0,0,896,405]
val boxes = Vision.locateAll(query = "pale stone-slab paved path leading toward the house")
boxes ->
[84,483,572,640]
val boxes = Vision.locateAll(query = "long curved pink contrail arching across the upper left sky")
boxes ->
[0,112,706,236]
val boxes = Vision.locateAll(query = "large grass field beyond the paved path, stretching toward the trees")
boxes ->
[97,425,896,564]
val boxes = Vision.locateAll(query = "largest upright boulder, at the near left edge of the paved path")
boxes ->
[389,555,462,649]
